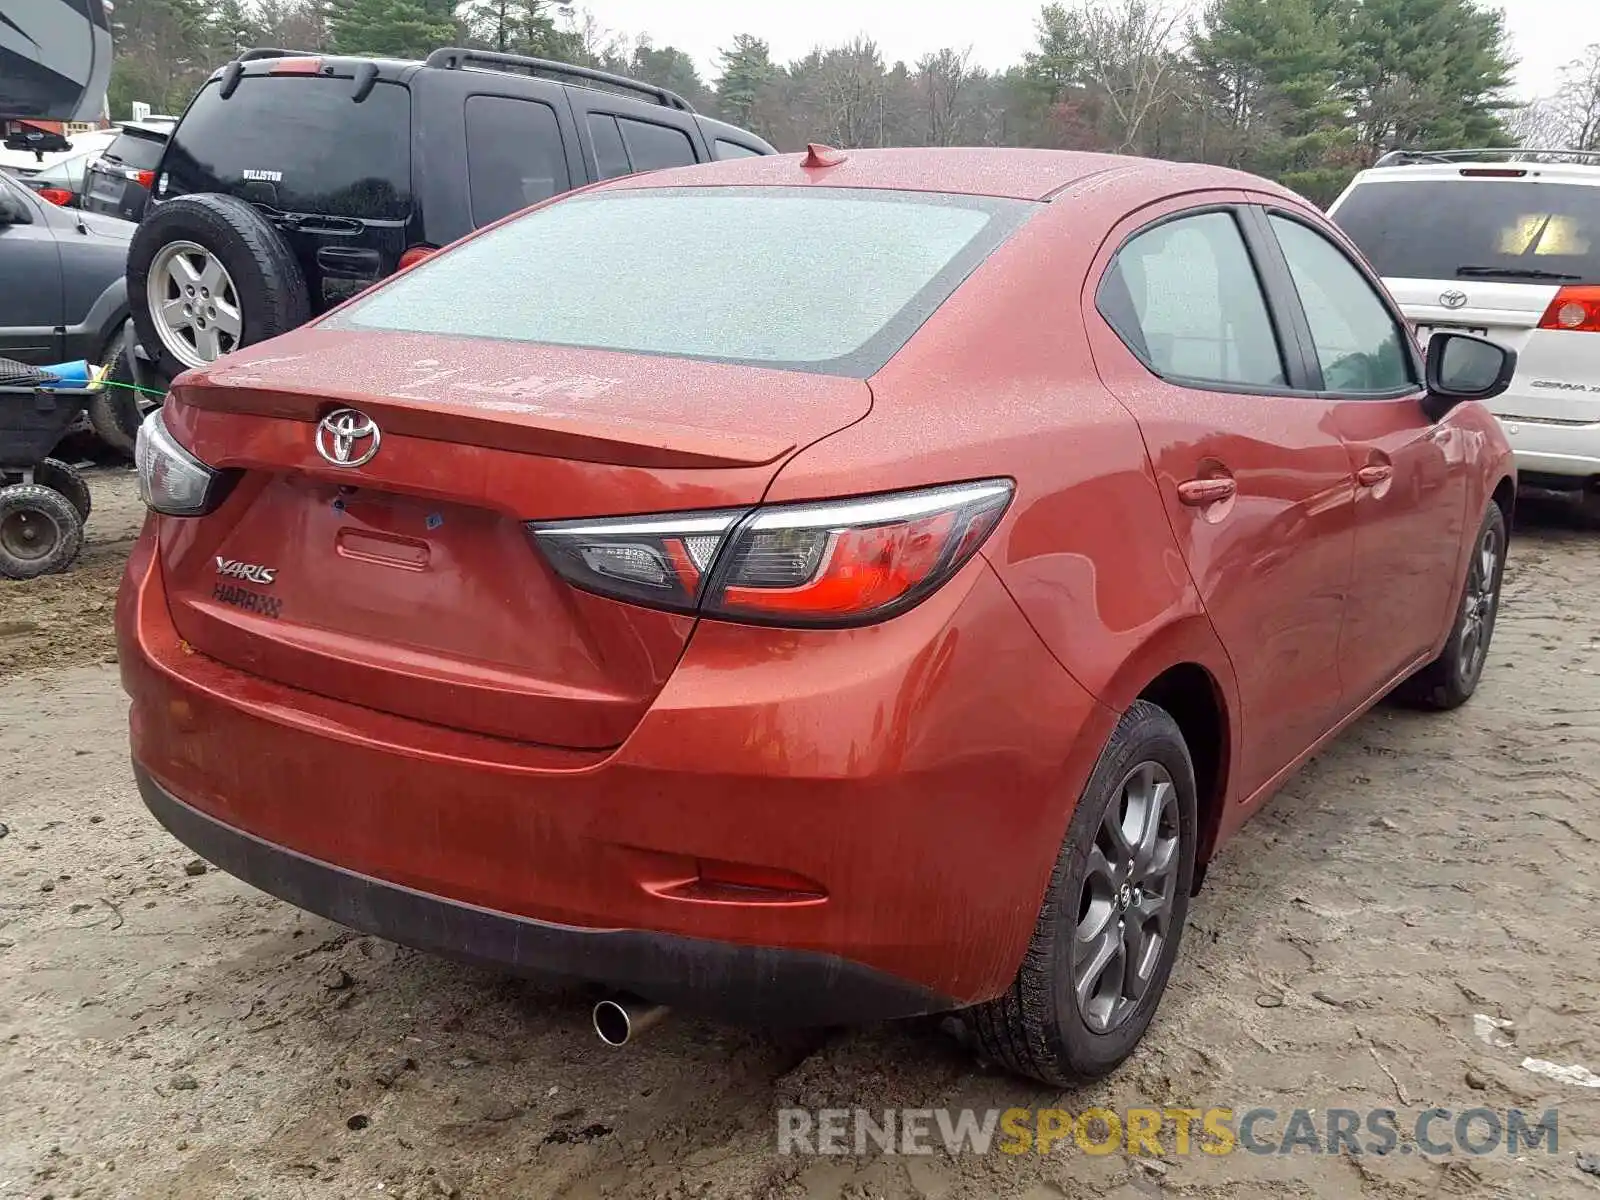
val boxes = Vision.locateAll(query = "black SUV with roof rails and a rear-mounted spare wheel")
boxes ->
[128,48,774,382]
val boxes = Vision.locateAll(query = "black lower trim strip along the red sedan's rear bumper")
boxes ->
[134,766,955,1026]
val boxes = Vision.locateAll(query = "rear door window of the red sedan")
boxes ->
[1098,213,1286,389]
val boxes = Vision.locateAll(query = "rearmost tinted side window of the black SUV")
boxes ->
[466,96,573,226]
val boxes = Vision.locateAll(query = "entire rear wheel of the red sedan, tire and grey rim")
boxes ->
[970,701,1195,1086]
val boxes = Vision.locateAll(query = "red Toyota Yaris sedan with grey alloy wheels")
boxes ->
[118,149,1515,1083]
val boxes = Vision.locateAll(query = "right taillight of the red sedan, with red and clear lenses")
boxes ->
[528,480,1013,626]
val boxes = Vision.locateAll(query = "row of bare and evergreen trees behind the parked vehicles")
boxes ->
[110,0,1600,202]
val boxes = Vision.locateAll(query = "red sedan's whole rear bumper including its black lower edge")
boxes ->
[117,528,1115,1024]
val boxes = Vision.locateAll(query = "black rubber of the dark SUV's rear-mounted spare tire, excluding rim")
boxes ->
[128,192,310,378]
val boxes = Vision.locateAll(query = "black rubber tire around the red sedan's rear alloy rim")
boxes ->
[968,701,1195,1086]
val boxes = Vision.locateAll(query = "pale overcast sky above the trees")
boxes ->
[578,0,1600,96]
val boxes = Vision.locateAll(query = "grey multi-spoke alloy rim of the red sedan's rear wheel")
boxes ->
[1072,760,1181,1034]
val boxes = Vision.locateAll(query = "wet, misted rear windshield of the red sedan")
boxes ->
[328,187,1037,378]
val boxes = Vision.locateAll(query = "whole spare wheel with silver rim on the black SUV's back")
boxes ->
[128,192,310,378]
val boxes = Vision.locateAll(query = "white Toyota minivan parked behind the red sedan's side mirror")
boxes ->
[1328,150,1600,517]
